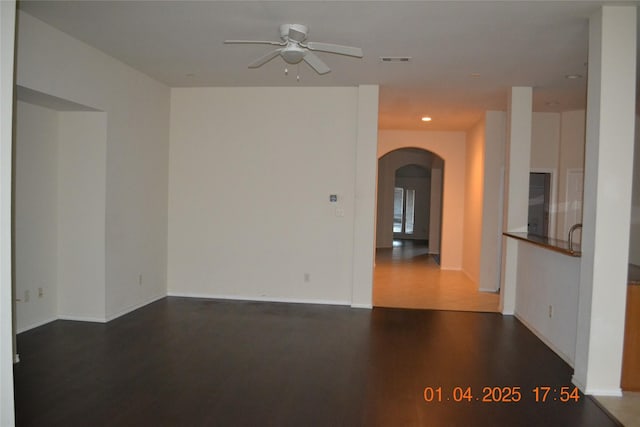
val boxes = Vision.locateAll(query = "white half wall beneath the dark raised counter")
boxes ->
[515,241,580,366]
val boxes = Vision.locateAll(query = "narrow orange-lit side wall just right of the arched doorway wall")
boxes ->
[462,120,485,285]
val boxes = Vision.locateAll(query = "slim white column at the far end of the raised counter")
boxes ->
[500,87,533,314]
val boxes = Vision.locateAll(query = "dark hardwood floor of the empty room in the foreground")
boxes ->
[15,298,620,427]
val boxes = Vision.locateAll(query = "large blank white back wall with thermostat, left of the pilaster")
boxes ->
[168,87,362,304]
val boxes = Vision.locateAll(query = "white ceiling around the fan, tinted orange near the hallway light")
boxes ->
[19,0,636,130]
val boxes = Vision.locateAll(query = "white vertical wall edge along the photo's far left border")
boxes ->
[0,0,16,426]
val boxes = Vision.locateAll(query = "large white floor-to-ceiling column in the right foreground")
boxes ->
[573,6,636,395]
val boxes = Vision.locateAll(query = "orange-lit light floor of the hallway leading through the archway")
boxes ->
[373,240,500,312]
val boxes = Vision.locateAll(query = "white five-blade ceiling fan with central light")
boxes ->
[224,24,362,74]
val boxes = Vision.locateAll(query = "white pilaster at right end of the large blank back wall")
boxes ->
[351,85,378,308]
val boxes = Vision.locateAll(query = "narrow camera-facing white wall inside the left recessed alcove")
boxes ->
[57,112,107,321]
